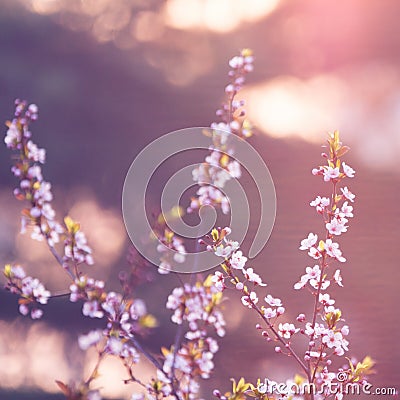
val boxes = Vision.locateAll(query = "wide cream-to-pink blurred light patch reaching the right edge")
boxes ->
[244,62,400,169]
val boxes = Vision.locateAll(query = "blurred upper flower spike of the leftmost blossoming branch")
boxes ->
[4,100,93,277]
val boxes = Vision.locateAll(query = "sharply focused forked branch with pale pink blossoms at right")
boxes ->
[204,132,374,400]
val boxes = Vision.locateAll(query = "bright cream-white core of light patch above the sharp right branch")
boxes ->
[242,75,347,141]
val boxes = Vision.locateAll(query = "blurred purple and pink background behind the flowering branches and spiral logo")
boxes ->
[0,0,400,399]
